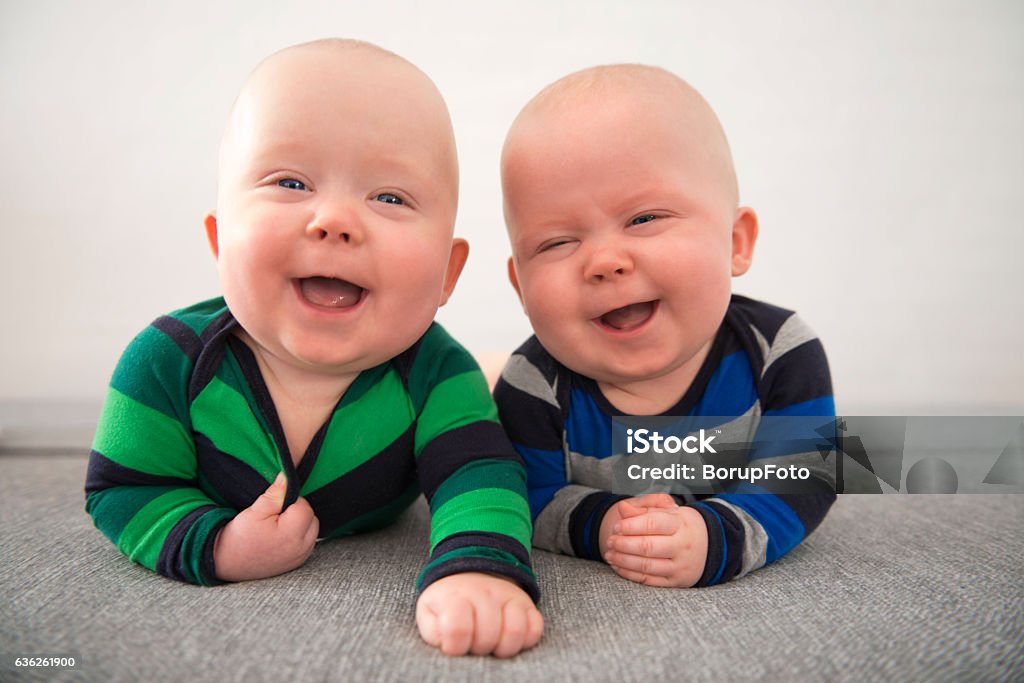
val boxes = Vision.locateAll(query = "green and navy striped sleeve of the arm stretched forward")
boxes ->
[410,328,540,602]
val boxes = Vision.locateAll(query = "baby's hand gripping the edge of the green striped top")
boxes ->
[213,474,319,581]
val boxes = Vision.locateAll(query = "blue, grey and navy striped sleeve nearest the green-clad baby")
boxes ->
[495,338,629,561]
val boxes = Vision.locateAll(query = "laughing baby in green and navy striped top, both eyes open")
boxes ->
[86,40,543,656]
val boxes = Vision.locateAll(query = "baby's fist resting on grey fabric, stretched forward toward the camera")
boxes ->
[416,571,544,657]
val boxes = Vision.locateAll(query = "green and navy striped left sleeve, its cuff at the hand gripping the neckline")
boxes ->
[85,317,237,586]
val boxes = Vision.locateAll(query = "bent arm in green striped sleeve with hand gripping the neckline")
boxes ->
[86,317,317,585]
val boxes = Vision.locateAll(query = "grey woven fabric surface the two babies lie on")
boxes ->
[0,455,1024,683]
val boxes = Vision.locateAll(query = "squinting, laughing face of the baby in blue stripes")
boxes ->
[503,89,756,393]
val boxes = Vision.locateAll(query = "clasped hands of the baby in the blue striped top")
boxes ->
[601,494,708,588]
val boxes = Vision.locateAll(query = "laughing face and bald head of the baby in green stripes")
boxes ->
[207,48,458,374]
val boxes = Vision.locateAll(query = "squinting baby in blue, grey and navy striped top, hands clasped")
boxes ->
[495,66,836,587]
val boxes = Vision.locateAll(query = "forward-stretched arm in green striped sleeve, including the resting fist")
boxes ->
[410,329,544,656]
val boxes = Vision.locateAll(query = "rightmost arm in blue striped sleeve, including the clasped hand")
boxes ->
[601,316,836,586]
